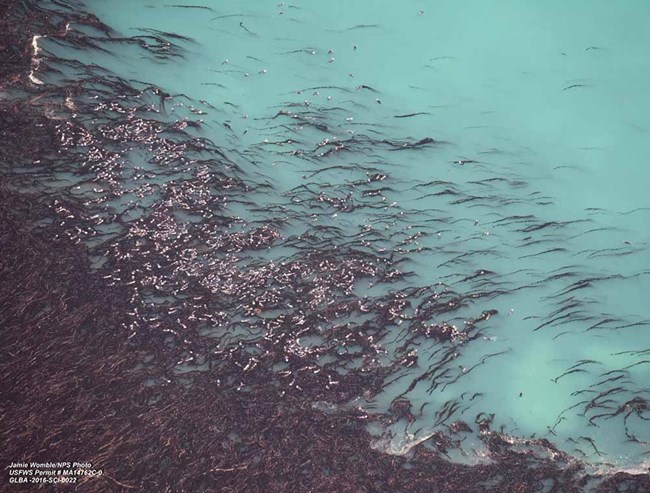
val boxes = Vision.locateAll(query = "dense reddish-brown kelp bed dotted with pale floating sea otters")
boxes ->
[0,0,650,493]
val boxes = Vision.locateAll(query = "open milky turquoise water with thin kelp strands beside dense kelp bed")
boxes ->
[36,0,650,470]
